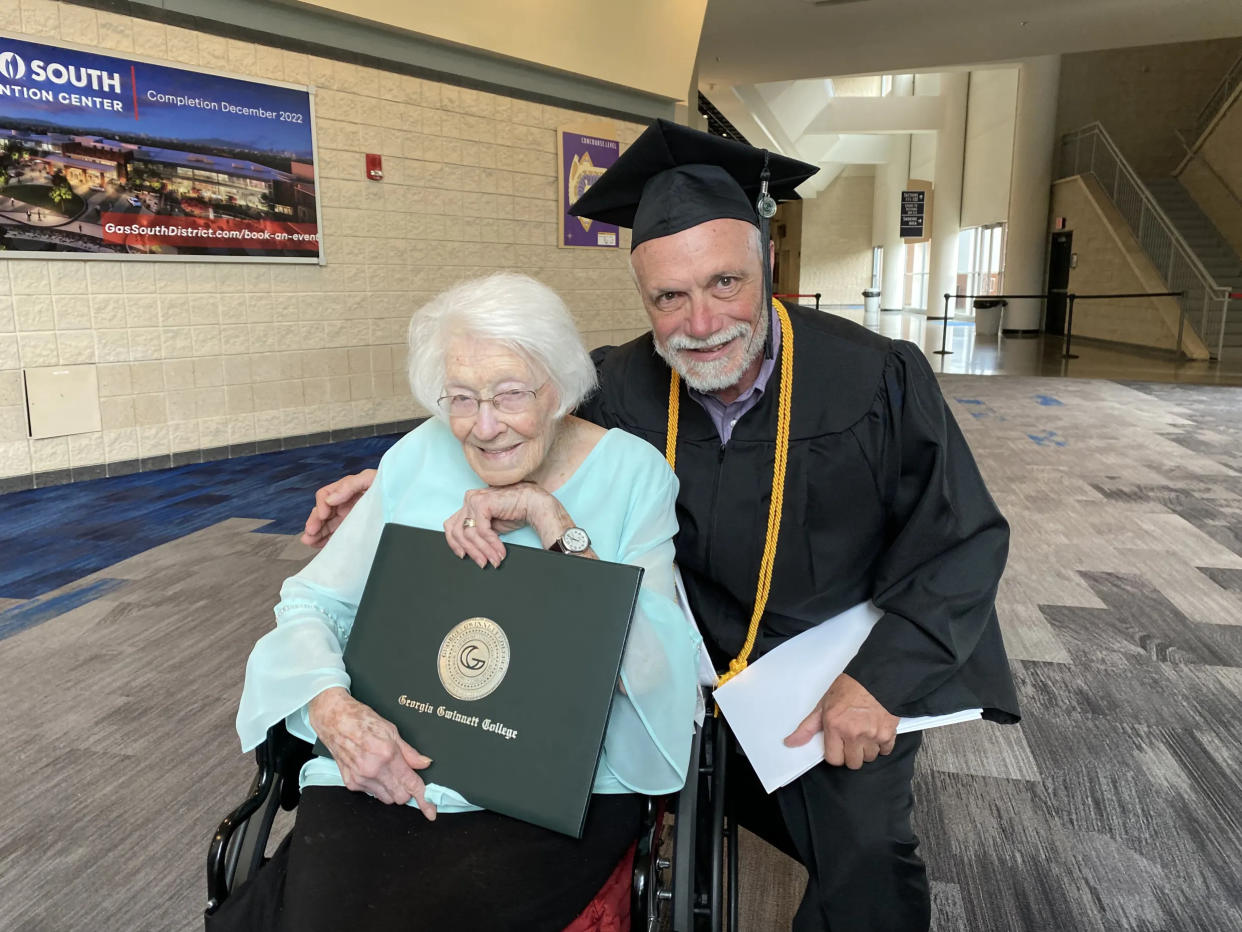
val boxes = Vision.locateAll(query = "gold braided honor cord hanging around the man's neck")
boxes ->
[664,298,794,688]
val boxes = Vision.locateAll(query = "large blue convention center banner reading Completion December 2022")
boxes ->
[0,36,320,262]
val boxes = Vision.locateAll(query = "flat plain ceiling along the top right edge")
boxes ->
[698,0,1242,88]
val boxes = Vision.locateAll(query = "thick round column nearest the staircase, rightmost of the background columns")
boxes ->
[1002,55,1061,333]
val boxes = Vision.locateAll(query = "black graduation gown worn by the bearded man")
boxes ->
[579,306,1018,722]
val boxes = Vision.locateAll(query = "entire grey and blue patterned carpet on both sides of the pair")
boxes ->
[0,377,1242,932]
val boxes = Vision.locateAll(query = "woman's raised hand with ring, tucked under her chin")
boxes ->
[445,482,574,568]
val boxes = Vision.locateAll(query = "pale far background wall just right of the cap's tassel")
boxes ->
[797,174,876,304]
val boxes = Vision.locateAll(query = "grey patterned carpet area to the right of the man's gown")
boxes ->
[917,377,1242,932]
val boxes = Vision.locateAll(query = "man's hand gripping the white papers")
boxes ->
[785,674,898,770]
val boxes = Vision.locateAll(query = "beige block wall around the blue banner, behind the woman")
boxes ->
[0,0,646,477]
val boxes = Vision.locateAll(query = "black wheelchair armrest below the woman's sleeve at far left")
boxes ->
[207,721,314,915]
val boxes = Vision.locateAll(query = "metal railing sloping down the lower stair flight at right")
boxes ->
[1061,123,1230,359]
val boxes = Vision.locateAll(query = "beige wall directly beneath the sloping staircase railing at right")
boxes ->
[1052,175,1208,359]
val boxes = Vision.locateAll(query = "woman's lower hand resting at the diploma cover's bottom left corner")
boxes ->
[309,686,436,820]
